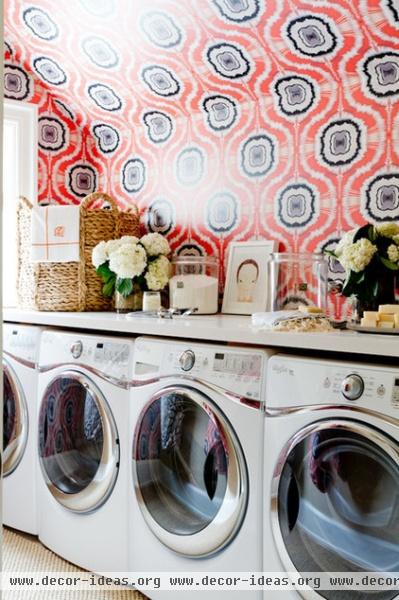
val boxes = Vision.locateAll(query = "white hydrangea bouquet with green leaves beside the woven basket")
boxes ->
[92,233,170,298]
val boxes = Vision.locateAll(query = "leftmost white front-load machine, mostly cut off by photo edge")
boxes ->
[3,323,41,534]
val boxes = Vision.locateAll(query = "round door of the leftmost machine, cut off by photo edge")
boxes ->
[3,359,29,477]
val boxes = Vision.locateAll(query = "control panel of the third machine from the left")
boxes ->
[134,339,265,401]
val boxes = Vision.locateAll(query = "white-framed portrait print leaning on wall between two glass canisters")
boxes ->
[222,240,277,315]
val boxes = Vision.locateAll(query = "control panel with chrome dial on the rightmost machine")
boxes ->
[267,355,399,416]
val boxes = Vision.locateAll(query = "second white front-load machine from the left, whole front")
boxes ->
[37,332,134,573]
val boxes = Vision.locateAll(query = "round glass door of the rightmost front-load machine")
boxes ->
[272,420,399,600]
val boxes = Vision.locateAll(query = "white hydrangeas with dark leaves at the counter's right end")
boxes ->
[327,223,399,310]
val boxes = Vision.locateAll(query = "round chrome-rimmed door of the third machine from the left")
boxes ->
[133,386,248,557]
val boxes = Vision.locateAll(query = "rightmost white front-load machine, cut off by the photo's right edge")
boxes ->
[264,354,399,600]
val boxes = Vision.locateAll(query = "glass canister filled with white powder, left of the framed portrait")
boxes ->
[169,255,219,315]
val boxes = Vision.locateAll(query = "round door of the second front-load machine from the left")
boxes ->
[39,370,119,513]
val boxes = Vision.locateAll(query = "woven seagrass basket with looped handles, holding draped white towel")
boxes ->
[17,192,140,311]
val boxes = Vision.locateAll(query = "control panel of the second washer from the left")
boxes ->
[39,332,133,377]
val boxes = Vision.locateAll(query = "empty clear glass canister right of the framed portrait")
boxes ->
[269,252,328,311]
